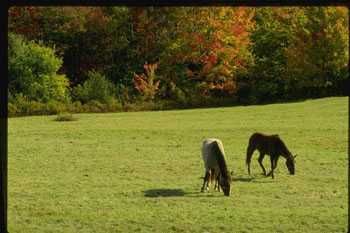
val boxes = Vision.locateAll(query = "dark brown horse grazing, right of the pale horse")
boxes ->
[246,133,296,178]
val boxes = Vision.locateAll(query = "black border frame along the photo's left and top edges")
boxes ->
[0,0,350,233]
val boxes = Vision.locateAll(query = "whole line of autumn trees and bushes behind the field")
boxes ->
[8,7,349,115]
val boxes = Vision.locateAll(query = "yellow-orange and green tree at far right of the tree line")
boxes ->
[286,7,349,95]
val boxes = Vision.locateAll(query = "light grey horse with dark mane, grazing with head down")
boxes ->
[201,138,231,196]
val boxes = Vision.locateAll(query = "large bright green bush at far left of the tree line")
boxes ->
[8,33,69,103]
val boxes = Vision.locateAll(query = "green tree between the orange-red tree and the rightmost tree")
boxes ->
[249,7,298,102]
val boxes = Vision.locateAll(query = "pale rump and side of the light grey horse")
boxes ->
[202,138,225,170]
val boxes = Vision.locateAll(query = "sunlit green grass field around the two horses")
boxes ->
[8,97,349,233]
